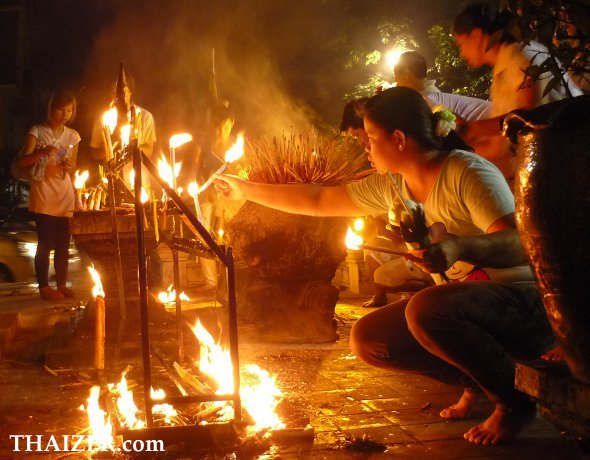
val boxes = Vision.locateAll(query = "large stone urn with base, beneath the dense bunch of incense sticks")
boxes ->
[227,202,347,343]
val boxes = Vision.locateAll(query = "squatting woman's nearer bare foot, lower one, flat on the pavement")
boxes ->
[463,404,536,445]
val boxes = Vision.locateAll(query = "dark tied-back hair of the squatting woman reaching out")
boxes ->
[365,86,472,155]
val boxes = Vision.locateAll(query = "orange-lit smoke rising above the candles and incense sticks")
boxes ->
[85,0,317,149]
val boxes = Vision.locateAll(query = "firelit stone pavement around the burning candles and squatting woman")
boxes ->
[0,286,588,460]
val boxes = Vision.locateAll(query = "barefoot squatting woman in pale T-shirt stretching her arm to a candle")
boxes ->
[216,87,554,444]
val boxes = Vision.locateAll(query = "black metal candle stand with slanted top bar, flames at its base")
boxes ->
[103,140,242,444]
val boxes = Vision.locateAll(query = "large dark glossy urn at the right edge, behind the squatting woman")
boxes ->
[505,96,590,382]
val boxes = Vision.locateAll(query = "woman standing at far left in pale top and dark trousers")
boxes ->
[19,91,80,300]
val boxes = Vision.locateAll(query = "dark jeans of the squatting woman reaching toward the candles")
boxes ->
[350,281,555,405]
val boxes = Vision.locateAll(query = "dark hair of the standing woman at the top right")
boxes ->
[453,2,514,42]
